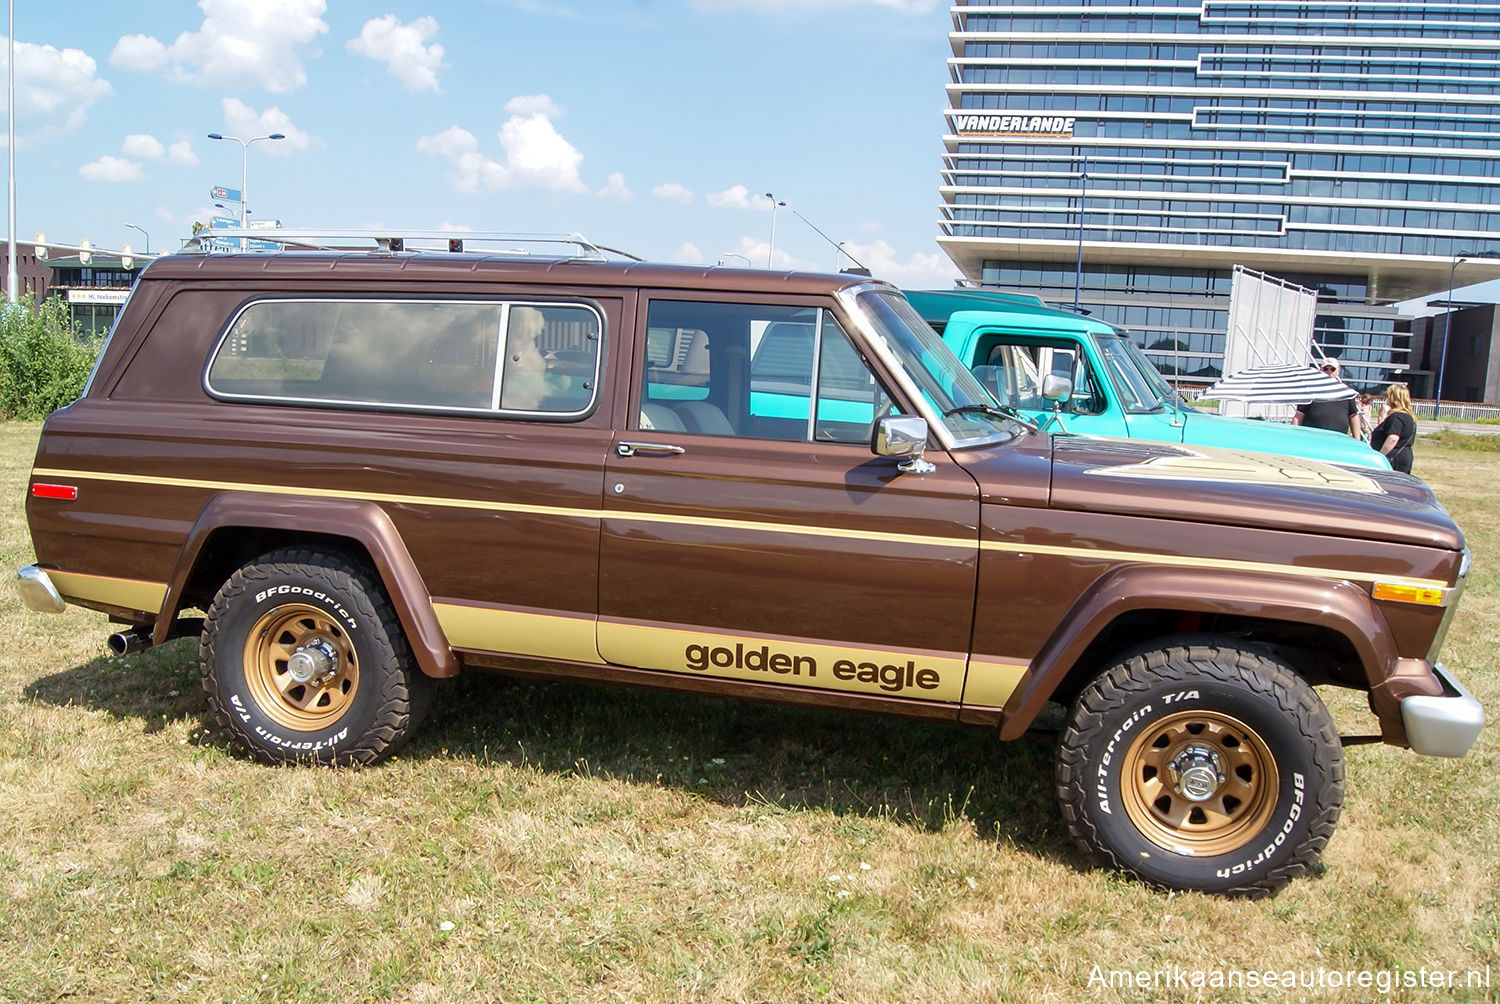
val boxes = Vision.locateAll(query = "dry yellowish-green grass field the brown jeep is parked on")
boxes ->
[0,425,1500,1004]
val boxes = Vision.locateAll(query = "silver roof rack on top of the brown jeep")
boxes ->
[183,227,641,261]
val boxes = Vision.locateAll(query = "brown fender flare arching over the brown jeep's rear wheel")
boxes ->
[152,492,459,677]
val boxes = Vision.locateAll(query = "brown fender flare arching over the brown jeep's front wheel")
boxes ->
[1001,564,1397,738]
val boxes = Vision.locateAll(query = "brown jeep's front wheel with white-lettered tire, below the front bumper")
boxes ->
[1058,638,1344,896]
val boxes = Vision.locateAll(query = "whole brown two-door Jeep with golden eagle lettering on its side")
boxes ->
[20,231,1484,893]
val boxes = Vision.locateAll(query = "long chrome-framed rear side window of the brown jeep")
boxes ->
[207,299,602,416]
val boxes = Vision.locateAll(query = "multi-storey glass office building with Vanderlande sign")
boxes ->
[939,0,1500,396]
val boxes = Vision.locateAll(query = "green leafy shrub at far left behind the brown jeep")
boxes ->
[0,297,101,419]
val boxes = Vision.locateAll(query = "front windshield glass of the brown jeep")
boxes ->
[860,293,1023,446]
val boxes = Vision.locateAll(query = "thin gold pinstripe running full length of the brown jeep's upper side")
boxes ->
[32,468,1449,588]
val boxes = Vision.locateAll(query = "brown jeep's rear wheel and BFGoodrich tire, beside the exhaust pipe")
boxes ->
[198,549,431,764]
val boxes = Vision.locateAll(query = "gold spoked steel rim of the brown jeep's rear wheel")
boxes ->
[245,603,360,732]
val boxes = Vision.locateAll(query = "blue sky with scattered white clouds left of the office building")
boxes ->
[0,0,957,285]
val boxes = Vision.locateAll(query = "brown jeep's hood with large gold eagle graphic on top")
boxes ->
[969,435,1464,551]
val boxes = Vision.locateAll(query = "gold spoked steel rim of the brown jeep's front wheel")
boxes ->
[1121,711,1281,857]
